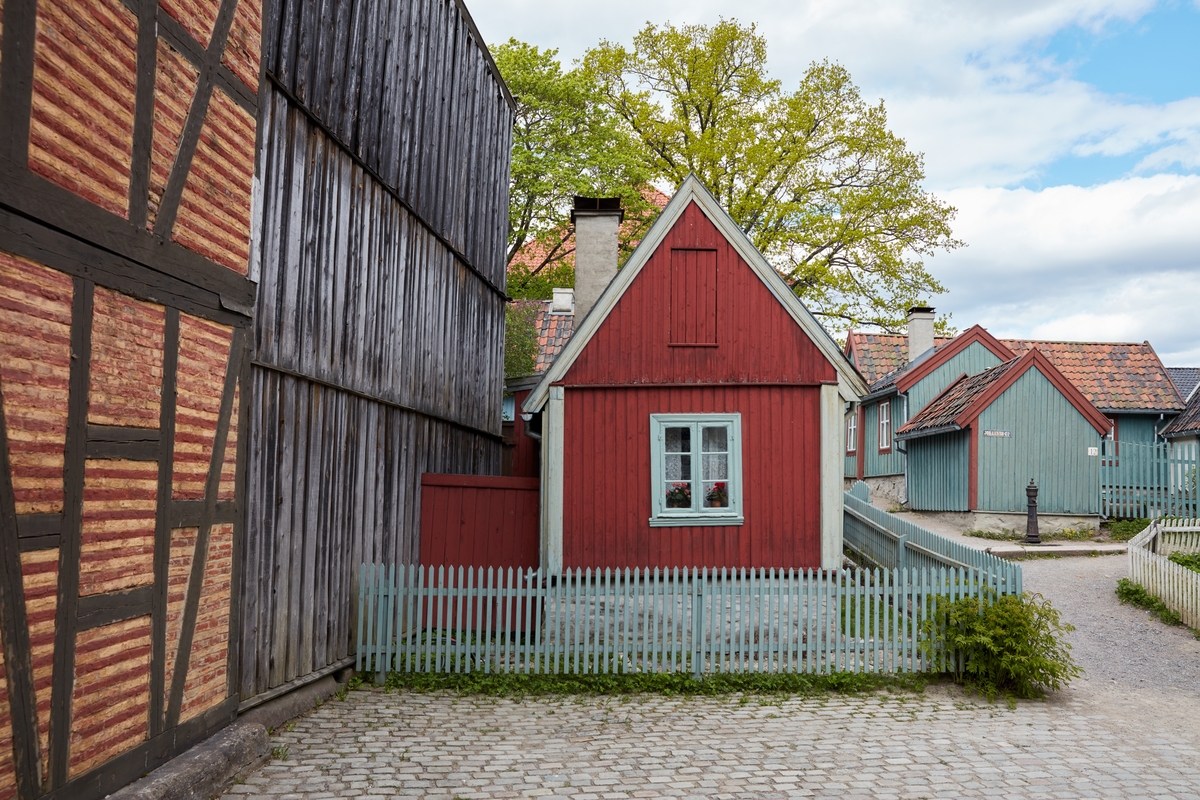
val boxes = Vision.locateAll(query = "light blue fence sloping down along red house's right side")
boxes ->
[842,481,1021,595]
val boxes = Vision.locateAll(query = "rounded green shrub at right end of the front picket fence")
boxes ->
[922,593,1084,700]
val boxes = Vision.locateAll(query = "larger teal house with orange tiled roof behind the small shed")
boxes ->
[845,325,1183,505]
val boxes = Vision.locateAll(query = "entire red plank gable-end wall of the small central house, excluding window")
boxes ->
[562,204,840,567]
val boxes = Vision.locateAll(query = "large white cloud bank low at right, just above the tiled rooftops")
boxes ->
[931,175,1200,366]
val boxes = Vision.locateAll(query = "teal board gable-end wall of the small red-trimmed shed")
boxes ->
[974,368,1099,515]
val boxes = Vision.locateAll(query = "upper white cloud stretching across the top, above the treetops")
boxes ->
[473,0,1200,191]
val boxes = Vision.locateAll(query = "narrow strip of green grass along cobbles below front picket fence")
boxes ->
[386,672,936,697]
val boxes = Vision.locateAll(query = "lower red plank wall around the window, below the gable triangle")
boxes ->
[563,386,821,569]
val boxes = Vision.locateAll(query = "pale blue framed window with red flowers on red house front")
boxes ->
[650,414,743,527]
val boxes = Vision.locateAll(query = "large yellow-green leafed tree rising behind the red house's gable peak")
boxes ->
[583,19,961,330]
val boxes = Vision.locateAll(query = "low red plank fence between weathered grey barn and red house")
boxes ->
[421,474,539,569]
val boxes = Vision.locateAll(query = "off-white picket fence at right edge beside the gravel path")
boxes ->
[1129,519,1200,628]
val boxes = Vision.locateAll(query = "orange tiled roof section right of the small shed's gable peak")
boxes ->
[1001,339,1183,411]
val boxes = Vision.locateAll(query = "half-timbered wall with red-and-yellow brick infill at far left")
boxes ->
[0,0,262,800]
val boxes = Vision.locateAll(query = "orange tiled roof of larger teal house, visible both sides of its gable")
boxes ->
[846,332,1183,411]
